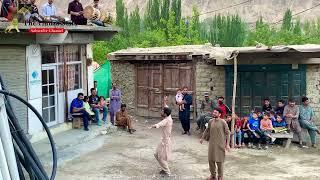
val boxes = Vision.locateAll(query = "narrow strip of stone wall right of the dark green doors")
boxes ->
[306,65,320,125]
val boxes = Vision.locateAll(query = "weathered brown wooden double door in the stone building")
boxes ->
[137,63,194,117]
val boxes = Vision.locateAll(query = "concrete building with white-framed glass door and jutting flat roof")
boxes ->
[0,23,118,141]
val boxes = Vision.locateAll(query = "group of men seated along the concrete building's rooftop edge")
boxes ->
[0,0,104,26]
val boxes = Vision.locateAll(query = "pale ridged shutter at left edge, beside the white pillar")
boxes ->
[0,45,28,131]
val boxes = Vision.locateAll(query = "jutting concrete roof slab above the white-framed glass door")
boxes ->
[0,22,120,44]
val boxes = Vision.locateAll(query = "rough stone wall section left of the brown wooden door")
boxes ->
[111,61,136,113]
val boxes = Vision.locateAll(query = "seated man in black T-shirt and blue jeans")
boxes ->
[89,88,108,126]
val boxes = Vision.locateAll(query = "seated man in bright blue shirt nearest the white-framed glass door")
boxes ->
[70,93,90,131]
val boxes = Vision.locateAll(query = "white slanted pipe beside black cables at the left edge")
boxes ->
[0,91,20,180]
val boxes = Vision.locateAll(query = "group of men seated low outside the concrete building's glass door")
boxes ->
[70,88,135,134]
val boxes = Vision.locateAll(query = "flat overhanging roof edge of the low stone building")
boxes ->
[108,44,320,65]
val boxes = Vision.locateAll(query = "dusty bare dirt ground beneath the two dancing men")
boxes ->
[56,119,320,180]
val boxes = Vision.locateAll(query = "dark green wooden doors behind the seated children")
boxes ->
[226,65,306,115]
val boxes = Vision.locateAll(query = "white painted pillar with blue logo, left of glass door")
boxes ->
[26,45,43,134]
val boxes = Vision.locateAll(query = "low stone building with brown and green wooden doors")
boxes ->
[109,45,320,123]
